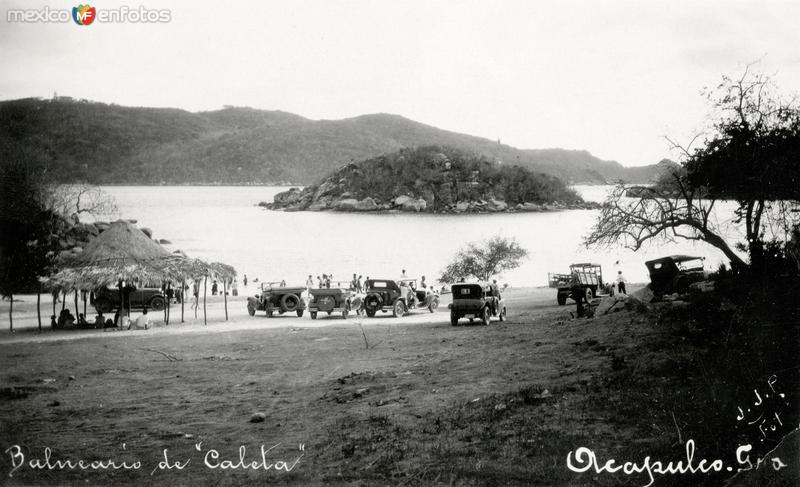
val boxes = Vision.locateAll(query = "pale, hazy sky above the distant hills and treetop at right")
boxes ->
[0,0,800,166]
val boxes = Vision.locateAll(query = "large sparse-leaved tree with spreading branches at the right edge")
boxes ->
[585,66,800,270]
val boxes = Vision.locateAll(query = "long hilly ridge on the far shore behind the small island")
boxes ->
[0,97,676,185]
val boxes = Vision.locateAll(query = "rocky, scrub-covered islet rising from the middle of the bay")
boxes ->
[259,146,599,213]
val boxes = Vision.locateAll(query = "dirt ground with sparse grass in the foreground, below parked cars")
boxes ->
[0,288,796,485]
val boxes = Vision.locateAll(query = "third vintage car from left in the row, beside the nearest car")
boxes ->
[363,279,439,317]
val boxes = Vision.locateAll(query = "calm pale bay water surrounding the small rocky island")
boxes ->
[98,186,736,286]
